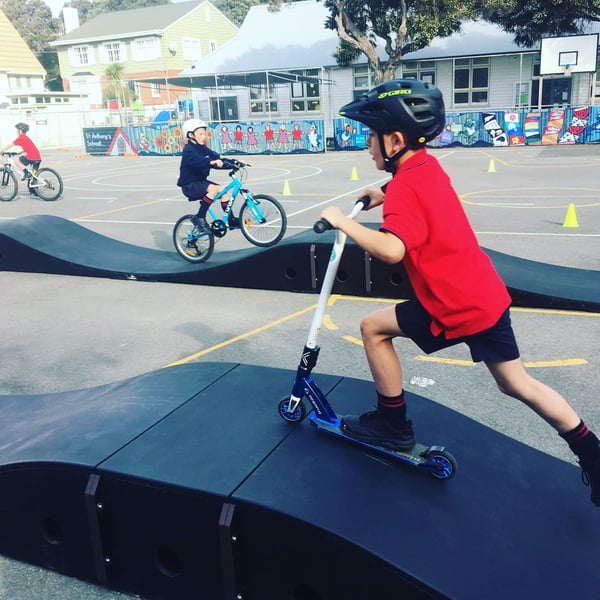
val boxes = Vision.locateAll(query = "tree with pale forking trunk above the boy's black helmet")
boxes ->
[325,0,476,83]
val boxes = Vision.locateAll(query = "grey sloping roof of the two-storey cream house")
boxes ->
[51,0,204,46]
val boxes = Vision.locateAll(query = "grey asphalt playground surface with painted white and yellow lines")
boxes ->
[0,145,600,600]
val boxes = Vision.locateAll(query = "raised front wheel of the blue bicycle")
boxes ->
[240,194,287,247]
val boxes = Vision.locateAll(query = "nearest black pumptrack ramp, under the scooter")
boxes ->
[0,363,600,600]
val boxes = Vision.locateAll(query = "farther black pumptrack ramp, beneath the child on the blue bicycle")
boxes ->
[0,215,600,311]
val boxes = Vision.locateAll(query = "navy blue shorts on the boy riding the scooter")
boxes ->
[396,300,519,362]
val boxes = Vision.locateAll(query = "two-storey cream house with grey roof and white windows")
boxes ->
[51,0,238,116]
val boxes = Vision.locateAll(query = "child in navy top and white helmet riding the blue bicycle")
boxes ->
[177,119,237,233]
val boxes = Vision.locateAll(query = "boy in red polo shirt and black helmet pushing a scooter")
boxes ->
[321,79,600,506]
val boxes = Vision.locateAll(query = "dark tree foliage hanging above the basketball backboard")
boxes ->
[480,0,600,47]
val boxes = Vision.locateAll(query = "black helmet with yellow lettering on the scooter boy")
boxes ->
[340,79,446,163]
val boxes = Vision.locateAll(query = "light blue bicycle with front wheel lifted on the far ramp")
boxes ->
[173,158,287,263]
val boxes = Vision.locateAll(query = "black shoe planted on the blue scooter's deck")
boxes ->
[342,410,415,451]
